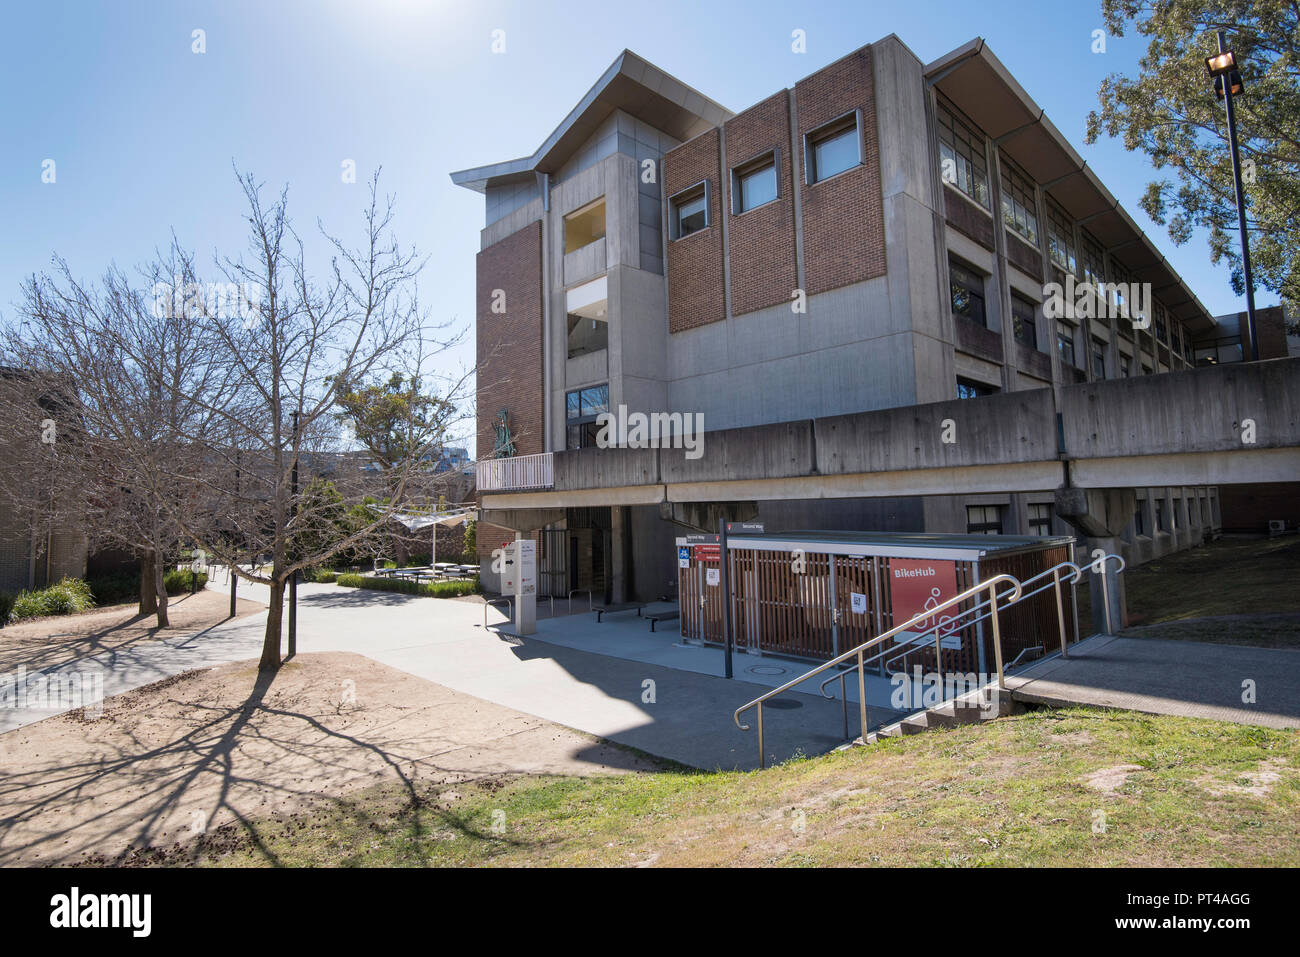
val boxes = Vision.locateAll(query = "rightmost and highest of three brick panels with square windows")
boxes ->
[794,48,885,294]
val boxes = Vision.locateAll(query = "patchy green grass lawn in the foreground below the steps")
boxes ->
[114,710,1300,867]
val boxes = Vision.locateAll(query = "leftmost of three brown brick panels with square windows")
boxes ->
[663,129,727,333]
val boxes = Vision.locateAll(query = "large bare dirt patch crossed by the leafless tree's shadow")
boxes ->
[0,650,655,866]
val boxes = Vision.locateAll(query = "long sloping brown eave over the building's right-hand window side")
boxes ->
[926,38,1214,333]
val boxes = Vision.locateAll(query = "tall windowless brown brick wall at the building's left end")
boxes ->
[476,222,546,459]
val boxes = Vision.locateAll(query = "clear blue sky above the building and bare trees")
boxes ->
[0,0,1273,426]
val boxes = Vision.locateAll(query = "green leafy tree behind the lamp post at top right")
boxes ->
[1087,0,1300,312]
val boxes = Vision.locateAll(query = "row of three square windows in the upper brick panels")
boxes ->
[668,112,862,239]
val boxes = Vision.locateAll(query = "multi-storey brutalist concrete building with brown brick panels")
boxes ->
[452,35,1248,601]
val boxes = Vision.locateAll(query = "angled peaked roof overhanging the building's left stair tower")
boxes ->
[451,49,732,192]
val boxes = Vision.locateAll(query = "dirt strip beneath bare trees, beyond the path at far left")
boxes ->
[0,590,267,674]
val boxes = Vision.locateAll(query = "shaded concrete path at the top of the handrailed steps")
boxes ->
[1006,635,1300,728]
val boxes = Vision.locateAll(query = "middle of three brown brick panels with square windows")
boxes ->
[724,90,798,316]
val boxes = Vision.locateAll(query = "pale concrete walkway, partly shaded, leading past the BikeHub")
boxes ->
[0,585,873,768]
